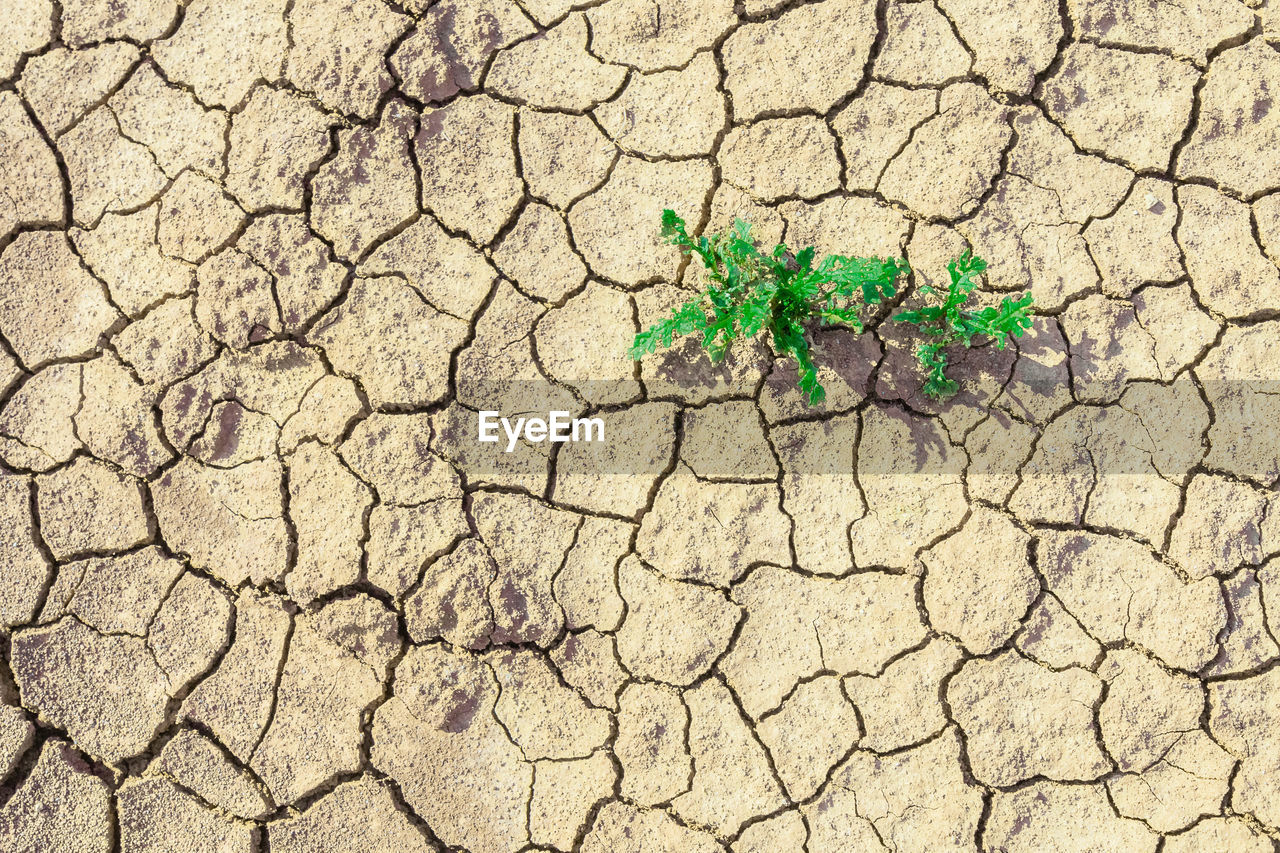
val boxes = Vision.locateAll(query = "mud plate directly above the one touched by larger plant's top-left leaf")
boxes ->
[594,51,728,158]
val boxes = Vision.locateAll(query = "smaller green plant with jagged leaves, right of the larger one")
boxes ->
[893,251,1032,400]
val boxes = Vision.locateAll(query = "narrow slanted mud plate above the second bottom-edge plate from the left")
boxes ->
[147,729,273,820]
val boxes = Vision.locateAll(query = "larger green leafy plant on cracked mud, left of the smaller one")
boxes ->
[630,210,910,405]
